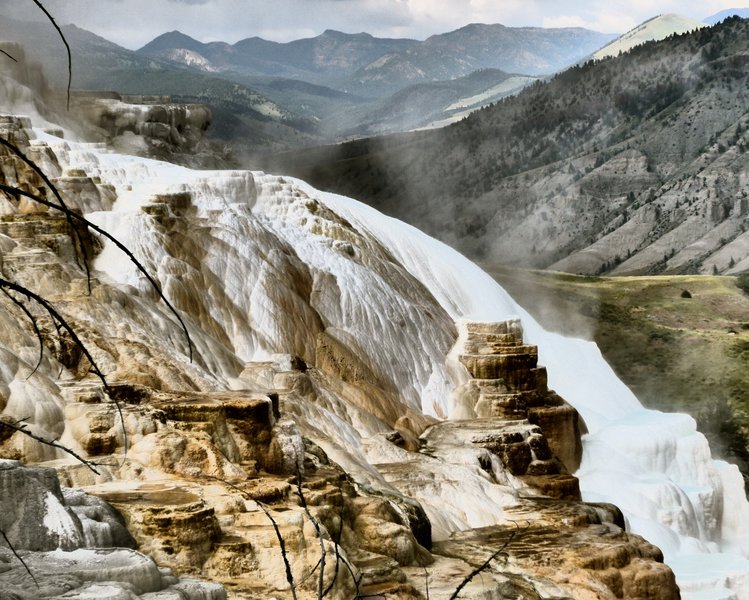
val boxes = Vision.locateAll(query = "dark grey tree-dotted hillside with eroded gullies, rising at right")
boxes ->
[263,19,749,274]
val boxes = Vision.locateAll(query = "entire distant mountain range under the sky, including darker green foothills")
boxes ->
[0,19,613,156]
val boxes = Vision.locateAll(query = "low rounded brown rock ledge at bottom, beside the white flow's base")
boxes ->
[435,500,679,600]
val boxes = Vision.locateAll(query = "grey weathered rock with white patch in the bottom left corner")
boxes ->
[0,460,226,600]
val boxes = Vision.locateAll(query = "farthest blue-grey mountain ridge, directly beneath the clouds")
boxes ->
[138,24,615,97]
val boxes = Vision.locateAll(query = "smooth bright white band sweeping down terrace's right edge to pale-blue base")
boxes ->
[297,182,749,598]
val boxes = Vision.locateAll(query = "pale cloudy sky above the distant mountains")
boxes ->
[7,0,746,49]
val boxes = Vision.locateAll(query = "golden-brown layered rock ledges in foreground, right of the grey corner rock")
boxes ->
[51,386,431,599]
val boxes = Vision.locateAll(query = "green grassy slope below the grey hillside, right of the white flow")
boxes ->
[483,264,749,474]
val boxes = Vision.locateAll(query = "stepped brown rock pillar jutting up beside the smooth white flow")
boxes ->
[456,320,582,499]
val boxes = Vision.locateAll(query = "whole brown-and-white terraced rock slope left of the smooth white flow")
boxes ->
[0,113,678,599]
